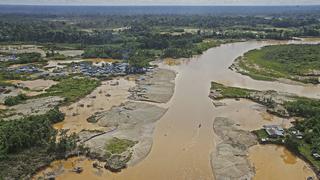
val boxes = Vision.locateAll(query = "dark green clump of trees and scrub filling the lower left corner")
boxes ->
[0,108,76,179]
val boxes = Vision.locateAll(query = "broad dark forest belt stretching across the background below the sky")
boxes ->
[0,14,320,66]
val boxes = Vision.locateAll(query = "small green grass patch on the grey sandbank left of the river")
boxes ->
[105,137,137,154]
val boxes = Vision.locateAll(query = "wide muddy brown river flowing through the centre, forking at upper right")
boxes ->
[35,41,320,180]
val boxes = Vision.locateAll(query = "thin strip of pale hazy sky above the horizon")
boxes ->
[0,0,320,5]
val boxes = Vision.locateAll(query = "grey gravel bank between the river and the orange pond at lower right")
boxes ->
[211,117,257,180]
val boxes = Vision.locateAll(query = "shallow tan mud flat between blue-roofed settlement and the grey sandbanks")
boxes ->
[54,78,135,133]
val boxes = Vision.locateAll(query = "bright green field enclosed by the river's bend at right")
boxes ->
[239,44,320,83]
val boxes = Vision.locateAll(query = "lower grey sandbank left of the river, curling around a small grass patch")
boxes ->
[84,102,166,171]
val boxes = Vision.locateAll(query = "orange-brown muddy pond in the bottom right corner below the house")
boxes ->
[249,145,315,180]
